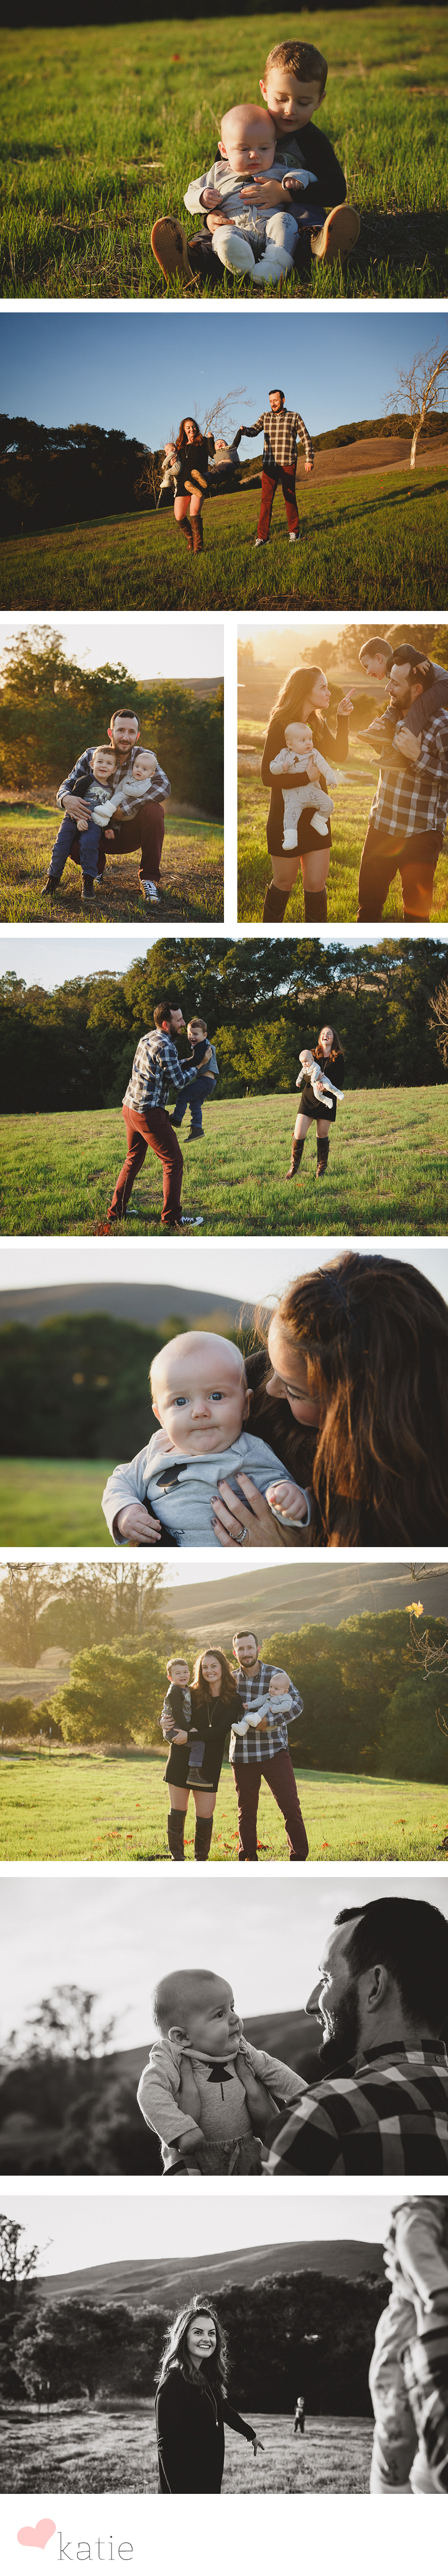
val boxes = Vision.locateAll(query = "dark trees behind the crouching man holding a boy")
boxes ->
[0,629,224,817]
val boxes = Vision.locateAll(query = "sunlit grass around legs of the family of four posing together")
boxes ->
[0,1746,448,1863]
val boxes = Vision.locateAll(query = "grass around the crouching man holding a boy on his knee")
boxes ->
[0,806,224,930]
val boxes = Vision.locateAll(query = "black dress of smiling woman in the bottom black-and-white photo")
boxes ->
[155,2362,255,2496]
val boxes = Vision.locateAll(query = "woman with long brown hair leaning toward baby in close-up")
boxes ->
[214,1252,448,1548]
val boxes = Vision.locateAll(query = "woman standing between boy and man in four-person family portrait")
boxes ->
[165,1646,242,1860]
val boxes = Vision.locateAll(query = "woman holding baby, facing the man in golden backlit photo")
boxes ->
[260,662,353,922]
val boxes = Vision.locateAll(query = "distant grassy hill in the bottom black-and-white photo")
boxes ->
[36,2236,383,2308]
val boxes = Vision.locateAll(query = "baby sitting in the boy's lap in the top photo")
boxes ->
[183,100,314,284]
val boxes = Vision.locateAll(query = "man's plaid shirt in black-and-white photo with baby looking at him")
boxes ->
[268,2040,448,2174]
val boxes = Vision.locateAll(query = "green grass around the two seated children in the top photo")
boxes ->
[0,7,448,299]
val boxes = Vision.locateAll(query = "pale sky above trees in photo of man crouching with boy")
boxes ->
[0,616,224,685]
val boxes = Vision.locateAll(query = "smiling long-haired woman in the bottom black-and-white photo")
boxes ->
[155,2292,262,2496]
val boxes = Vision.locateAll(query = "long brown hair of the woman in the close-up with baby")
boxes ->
[261,1252,448,1545]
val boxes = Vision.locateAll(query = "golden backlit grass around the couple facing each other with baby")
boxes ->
[237,721,448,922]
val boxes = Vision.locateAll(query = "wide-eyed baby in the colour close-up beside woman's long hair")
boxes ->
[103,1332,309,1548]
